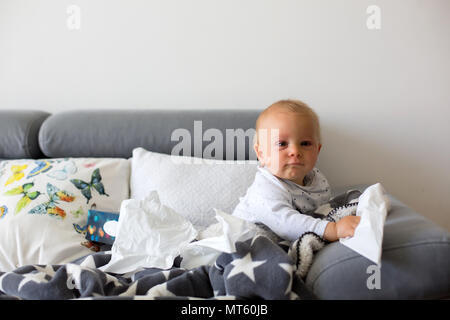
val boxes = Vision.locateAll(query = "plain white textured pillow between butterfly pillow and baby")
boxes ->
[130,148,257,229]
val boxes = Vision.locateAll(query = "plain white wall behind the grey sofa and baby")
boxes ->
[0,0,450,230]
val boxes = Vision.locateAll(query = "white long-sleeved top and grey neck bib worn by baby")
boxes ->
[233,167,331,241]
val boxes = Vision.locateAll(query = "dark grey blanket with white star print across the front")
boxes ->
[0,235,314,300]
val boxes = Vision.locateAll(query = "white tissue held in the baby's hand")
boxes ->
[339,183,390,266]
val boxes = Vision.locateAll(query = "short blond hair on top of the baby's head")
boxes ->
[253,99,322,143]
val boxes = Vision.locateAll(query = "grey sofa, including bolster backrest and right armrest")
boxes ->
[0,110,450,299]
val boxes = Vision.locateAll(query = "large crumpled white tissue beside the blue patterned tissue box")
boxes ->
[99,191,197,273]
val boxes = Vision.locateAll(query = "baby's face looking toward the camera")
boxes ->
[255,111,322,185]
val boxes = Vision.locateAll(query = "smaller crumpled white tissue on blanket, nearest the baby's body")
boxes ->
[180,208,258,269]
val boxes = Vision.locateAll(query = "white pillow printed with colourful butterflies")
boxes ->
[0,158,130,271]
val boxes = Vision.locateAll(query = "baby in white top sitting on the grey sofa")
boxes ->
[233,100,360,241]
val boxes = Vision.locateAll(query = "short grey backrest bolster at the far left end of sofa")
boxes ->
[0,110,50,159]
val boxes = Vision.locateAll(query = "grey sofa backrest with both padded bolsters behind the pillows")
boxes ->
[0,109,260,160]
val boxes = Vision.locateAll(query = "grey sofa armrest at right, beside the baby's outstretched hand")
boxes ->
[306,187,450,299]
